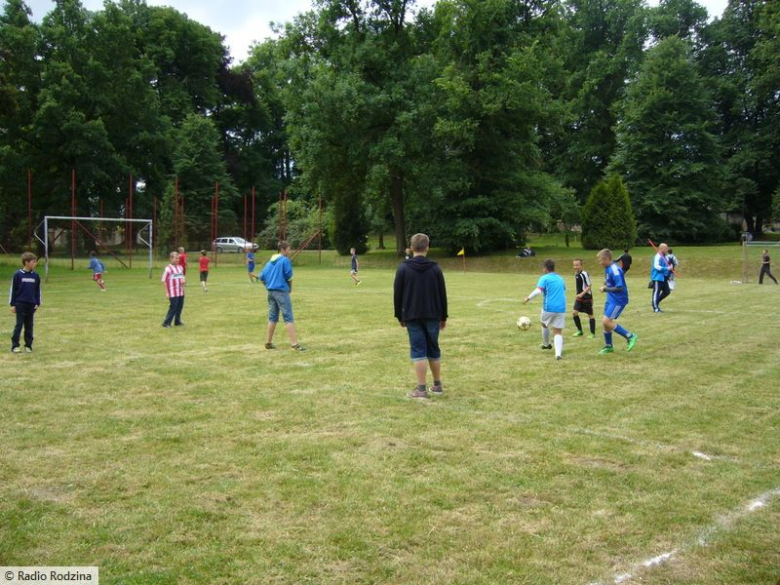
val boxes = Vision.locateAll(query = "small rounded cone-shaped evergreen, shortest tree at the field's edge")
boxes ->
[582,175,637,250]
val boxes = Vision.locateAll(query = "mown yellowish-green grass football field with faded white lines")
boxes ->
[0,241,780,585]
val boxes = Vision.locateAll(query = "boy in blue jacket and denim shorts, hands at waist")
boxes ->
[259,241,306,351]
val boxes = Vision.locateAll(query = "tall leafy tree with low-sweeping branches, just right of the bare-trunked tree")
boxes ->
[416,0,560,252]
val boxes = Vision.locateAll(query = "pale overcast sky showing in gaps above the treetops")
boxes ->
[22,0,727,63]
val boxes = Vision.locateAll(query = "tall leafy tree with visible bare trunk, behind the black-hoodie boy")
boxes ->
[282,0,436,254]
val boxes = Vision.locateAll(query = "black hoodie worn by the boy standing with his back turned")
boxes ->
[393,256,447,323]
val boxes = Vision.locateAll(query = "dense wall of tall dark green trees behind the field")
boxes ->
[0,0,780,254]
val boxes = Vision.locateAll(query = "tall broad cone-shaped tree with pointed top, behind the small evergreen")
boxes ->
[612,37,726,242]
